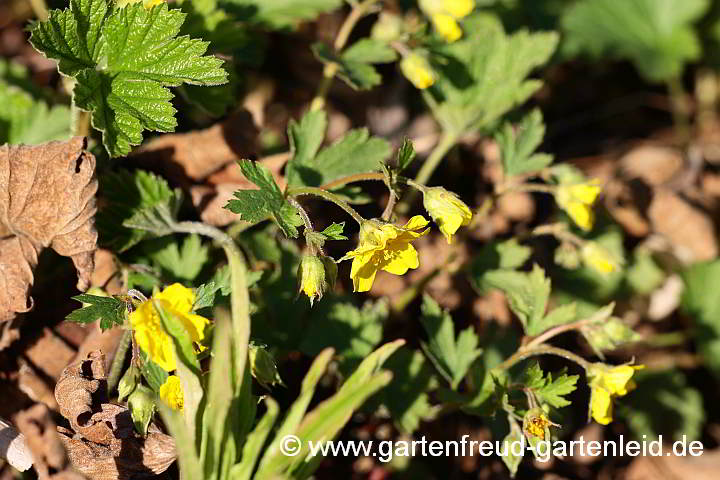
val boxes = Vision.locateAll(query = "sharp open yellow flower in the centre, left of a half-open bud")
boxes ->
[342,215,430,292]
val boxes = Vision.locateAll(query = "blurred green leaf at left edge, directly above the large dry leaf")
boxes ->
[0,76,70,145]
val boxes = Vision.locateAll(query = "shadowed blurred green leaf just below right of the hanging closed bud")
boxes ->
[300,297,389,368]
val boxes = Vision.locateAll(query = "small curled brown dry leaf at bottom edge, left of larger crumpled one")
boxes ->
[17,404,85,480]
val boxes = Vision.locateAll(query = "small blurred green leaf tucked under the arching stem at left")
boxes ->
[148,234,210,281]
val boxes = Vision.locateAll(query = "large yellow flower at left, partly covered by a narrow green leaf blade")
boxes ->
[130,283,209,372]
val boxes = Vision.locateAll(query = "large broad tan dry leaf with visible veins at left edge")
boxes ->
[0,137,97,322]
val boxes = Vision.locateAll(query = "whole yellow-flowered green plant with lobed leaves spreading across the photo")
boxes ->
[0,0,664,480]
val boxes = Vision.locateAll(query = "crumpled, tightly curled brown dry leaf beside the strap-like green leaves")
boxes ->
[55,351,176,480]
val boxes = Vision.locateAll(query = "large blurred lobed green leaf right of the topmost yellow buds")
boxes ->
[424,13,558,135]
